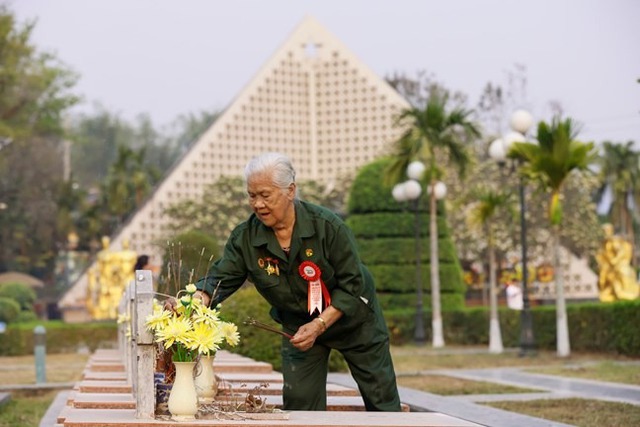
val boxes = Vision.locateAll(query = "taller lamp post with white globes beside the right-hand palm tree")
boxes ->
[489,110,536,356]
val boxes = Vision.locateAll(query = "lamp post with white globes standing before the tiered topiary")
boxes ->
[391,161,446,344]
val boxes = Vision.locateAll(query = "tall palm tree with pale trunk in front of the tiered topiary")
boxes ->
[386,92,480,348]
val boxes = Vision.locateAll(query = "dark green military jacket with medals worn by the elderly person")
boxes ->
[196,200,388,348]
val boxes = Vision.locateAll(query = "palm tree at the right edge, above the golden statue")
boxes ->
[598,141,640,254]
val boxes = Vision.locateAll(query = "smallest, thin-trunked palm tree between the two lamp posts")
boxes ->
[469,188,514,354]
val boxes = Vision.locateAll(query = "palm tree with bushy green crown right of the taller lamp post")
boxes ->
[508,117,595,357]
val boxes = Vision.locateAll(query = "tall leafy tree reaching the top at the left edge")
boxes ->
[0,5,78,277]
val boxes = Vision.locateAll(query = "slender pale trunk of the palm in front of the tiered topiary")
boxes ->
[429,179,444,348]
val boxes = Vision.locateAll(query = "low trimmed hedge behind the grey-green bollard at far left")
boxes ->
[0,320,118,356]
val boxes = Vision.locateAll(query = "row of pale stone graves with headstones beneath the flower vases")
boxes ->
[54,270,478,427]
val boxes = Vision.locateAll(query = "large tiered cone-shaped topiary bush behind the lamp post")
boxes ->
[346,158,466,312]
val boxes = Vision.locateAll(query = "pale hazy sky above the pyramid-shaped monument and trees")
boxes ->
[10,0,640,147]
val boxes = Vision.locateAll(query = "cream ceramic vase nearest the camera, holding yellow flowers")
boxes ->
[167,362,198,421]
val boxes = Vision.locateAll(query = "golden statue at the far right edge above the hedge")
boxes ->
[596,224,640,302]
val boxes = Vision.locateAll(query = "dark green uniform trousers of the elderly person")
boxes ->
[282,339,400,412]
